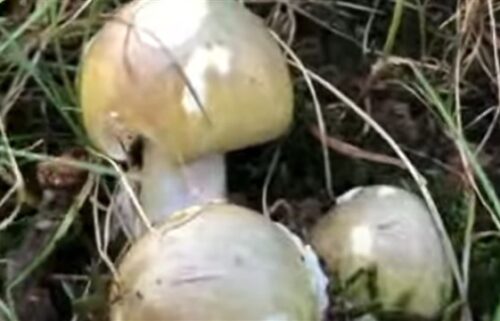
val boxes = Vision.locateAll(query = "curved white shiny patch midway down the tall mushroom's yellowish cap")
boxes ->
[182,45,231,115]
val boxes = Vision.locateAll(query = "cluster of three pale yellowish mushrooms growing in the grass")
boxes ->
[79,0,451,321]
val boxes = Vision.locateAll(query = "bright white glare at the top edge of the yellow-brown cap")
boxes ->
[134,0,209,50]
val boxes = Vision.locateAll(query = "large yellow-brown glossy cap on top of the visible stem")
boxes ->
[79,0,293,161]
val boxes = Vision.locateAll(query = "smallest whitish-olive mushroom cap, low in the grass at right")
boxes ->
[312,185,452,318]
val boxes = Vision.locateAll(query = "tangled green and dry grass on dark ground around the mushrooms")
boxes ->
[0,0,500,321]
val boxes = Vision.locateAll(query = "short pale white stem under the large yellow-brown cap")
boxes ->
[135,144,226,234]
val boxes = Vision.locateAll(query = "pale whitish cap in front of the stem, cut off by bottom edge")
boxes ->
[111,204,326,321]
